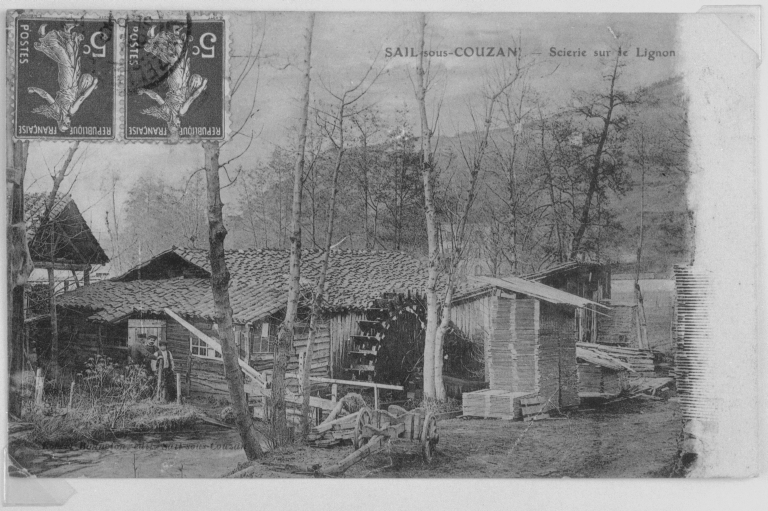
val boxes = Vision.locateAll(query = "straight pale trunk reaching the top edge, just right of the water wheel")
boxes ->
[416,13,440,398]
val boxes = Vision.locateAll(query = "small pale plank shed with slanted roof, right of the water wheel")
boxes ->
[452,277,603,417]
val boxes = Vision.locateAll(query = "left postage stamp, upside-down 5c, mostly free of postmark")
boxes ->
[14,17,116,140]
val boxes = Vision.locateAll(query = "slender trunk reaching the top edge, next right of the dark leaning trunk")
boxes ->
[271,13,315,445]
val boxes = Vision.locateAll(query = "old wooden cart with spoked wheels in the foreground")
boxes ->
[313,407,440,475]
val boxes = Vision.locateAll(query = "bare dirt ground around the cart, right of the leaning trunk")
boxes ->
[232,398,682,478]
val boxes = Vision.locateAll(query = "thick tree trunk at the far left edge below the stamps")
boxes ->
[6,140,33,417]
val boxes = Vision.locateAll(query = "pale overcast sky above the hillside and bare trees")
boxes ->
[26,12,681,250]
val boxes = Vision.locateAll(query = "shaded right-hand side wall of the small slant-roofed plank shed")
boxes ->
[538,301,579,409]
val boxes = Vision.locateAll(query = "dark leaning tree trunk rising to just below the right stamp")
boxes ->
[203,142,266,460]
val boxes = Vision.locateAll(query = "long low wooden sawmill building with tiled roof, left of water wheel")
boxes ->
[60,247,425,397]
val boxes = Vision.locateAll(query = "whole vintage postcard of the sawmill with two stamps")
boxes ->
[3,3,762,504]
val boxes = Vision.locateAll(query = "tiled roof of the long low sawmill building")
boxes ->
[59,248,427,323]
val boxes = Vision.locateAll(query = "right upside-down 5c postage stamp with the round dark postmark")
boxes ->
[123,18,226,141]
